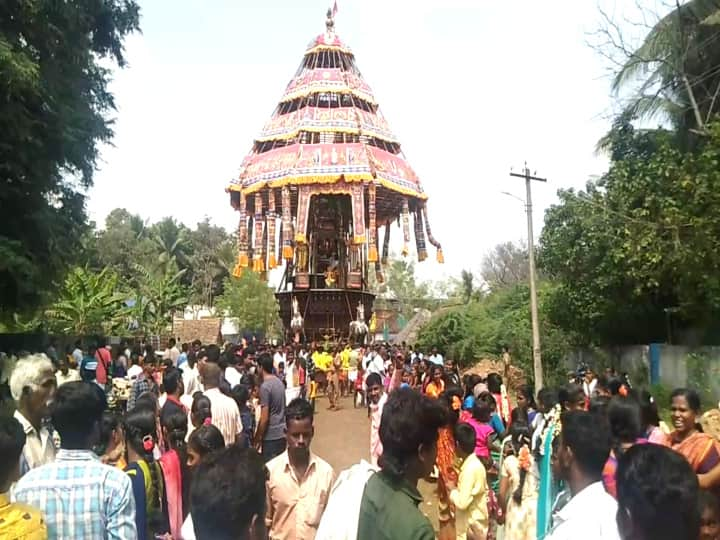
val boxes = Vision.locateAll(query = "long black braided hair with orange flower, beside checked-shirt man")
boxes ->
[123,407,163,530]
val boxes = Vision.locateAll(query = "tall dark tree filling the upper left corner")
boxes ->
[0,0,139,317]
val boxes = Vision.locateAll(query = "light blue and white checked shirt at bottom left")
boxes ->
[15,449,137,540]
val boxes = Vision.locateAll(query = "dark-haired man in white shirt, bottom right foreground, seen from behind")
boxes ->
[546,411,620,540]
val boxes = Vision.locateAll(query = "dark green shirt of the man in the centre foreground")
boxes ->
[357,472,435,540]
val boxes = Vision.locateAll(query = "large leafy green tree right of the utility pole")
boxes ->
[540,117,720,343]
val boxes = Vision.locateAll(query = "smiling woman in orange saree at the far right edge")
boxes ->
[670,388,720,494]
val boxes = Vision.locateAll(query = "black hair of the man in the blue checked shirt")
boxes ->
[50,381,107,450]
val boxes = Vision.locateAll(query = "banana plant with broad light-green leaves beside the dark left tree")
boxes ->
[44,267,126,336]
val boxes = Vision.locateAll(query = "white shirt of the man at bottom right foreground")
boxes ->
[546,482,620,540]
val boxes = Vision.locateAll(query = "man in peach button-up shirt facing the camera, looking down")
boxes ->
[265,398,335,540]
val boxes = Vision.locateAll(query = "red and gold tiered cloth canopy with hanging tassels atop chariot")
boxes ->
[227,12,442,276]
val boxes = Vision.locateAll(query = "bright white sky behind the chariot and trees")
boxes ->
[88,0,656,282]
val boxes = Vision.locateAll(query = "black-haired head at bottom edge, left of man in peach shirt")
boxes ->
[190,446,267,540]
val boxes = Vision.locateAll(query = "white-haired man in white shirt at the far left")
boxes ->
[10,354,57,475]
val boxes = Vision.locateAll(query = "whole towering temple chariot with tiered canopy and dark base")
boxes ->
[227,11,443,340]
